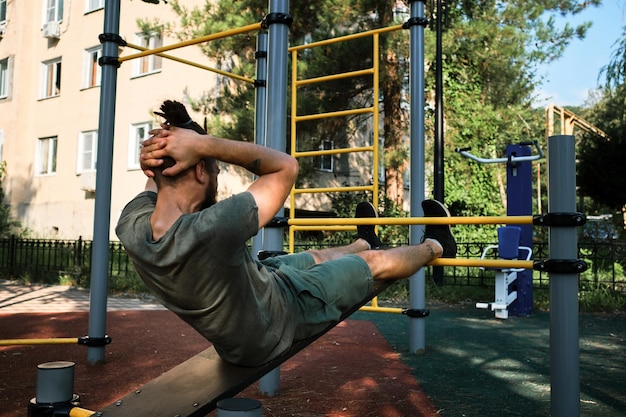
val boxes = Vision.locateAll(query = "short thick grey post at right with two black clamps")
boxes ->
[548,135,580,417]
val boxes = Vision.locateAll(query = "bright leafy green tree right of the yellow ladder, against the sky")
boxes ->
[426,0,599,236]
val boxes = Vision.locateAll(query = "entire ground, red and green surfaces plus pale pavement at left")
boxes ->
[0,281,626,417]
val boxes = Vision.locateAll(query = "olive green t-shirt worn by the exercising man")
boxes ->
[116,191,296,366]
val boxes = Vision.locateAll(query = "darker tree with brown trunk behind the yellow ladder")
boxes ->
[167,0,407,203]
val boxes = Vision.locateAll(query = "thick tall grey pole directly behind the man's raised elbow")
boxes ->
[259,0,289,397]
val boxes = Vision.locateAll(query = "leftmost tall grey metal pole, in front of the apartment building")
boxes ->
[87,0,120,364]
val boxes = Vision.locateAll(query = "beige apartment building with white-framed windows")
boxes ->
[0,0,260,239]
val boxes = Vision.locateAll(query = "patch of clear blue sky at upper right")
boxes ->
[535,0,626,107]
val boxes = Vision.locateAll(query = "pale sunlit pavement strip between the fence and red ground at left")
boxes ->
[0,280,164,314]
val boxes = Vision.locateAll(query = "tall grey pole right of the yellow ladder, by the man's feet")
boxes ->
[409,0,426,352]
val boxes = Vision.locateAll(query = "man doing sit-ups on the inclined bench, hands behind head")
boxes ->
[116,101,456,366]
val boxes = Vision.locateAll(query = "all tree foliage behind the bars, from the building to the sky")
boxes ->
[162,0,600,236]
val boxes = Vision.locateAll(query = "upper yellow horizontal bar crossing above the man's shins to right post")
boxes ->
[288,216,533,226]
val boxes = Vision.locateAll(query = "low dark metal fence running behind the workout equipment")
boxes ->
[0,237,626,294]
